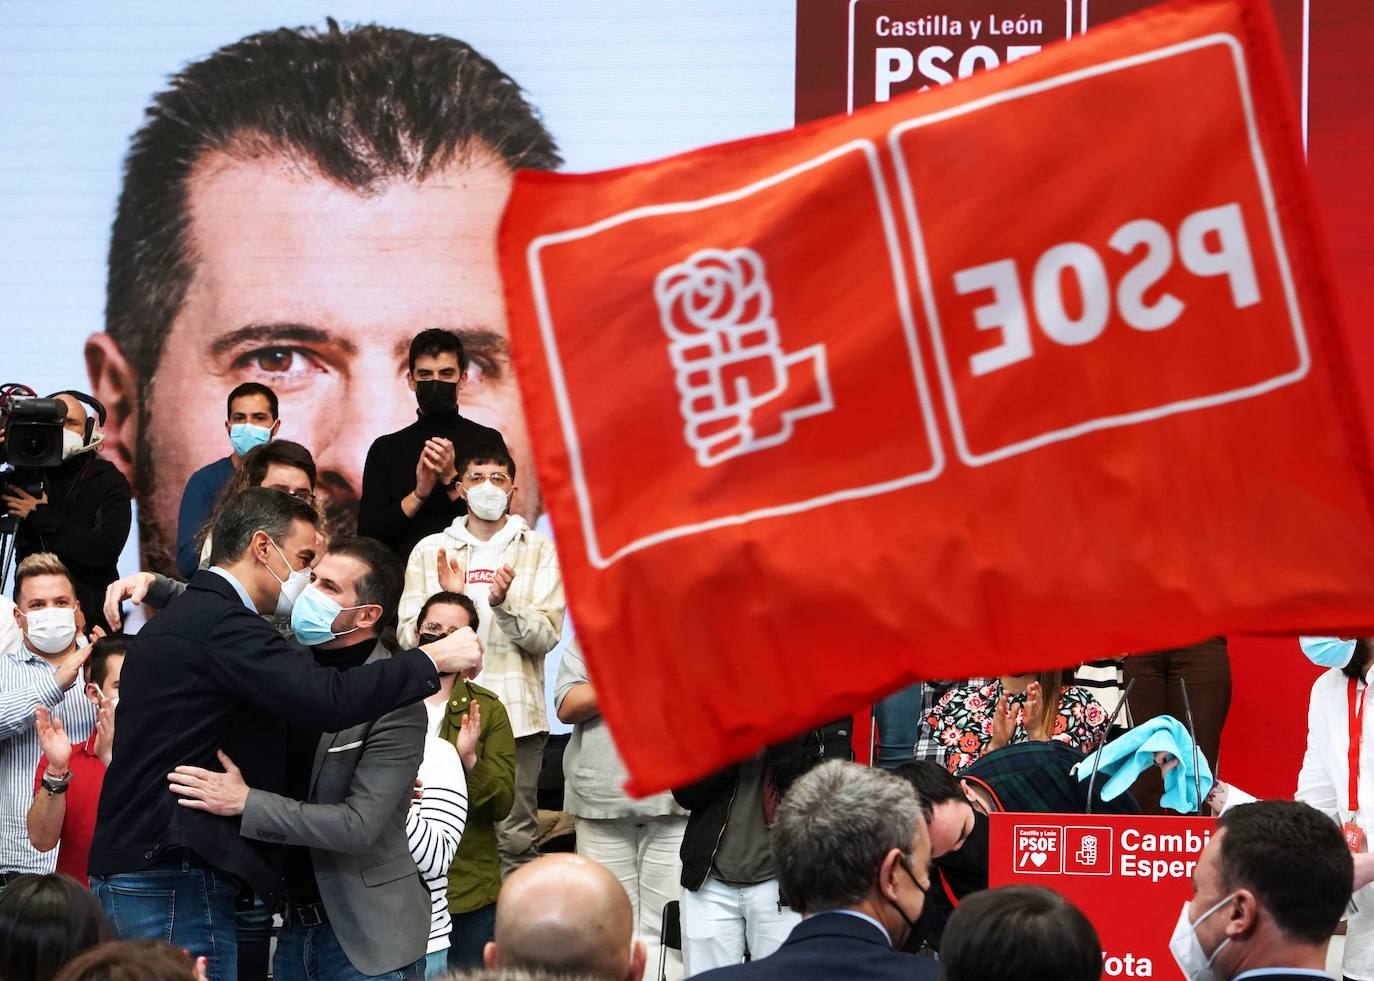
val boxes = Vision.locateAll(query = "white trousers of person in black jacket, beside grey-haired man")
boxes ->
[682,877,801,977]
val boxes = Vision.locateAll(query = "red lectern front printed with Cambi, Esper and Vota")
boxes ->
[988,813,1216,978]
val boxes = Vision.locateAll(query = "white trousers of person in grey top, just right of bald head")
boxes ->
[577,815,687,981]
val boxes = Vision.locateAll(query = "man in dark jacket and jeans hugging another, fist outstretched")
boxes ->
[91,488,481,981]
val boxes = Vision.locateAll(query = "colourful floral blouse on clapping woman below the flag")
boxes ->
[921,679,1107,774]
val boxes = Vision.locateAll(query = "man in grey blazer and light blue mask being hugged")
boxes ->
[169,539,430,981]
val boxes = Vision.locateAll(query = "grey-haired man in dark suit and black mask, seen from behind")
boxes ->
[699,761,938,981]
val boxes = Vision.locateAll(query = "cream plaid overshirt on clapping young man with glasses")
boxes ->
[396,517,563,739]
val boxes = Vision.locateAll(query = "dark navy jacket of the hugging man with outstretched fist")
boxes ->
[91,572,438,900]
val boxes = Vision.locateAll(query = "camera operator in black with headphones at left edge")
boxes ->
[0,392,132,629]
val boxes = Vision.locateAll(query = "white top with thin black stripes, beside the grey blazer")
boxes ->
[405,734,467,954]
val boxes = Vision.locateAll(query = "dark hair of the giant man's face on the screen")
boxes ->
[106,19,562,384]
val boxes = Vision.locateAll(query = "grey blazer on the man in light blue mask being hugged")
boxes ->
[240,643,430,974]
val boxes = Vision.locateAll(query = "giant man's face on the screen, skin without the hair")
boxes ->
[88,153,539,565]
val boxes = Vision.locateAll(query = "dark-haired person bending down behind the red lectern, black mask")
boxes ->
[893,742,1140,951]
